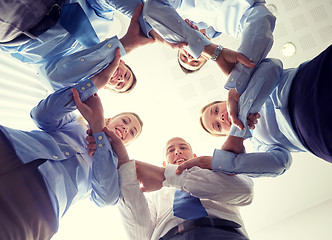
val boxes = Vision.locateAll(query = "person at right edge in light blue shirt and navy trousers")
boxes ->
[179,46,332,177]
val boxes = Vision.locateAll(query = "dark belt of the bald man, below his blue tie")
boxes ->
[159,217,241,240]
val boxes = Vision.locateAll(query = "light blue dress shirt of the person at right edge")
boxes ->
[212,59,308,177]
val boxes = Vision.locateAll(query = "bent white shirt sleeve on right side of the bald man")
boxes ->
[164,165,253,206]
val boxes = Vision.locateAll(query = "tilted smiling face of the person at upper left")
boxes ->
[107,60,134,93]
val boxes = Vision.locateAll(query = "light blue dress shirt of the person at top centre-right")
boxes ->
[143,0,275,93]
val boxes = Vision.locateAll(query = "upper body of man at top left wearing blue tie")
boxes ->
[0,0,153,92]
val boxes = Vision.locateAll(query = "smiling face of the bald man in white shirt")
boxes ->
[166,137,194,165]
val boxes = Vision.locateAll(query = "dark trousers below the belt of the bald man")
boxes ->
[170,227,248,240]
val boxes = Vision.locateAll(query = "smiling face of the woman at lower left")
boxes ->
[106,113,142,146]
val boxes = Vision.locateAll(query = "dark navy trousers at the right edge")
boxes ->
[288,45,332,163]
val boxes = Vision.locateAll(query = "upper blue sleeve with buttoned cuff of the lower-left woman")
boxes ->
[30,79,97,130]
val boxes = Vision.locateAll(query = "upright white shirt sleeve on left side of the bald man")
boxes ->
[118,161,155,240]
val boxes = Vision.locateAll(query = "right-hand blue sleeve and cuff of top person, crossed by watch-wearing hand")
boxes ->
[225,4,276,94]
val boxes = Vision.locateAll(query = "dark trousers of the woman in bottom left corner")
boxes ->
[0,131,58,240]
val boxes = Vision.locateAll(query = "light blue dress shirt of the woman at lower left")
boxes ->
[0,79,120,225]
